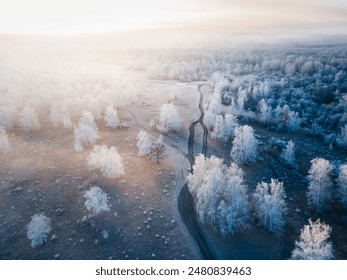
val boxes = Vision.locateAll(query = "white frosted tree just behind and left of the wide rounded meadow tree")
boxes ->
[74,111,99,152]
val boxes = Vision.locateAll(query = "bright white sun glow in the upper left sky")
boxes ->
[0,0,200,35]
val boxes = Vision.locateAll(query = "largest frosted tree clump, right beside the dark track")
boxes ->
[188,154,250,236]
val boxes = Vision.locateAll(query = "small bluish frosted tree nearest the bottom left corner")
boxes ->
[27,214,52,248]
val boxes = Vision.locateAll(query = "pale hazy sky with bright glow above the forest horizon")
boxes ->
[0,0,347,46]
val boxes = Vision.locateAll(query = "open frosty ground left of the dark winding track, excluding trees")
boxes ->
[0,64,199,259]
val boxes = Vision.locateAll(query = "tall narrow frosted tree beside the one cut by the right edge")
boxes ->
[307,158,333,212]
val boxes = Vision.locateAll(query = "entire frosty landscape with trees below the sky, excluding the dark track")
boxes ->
[0,46,347,259]
